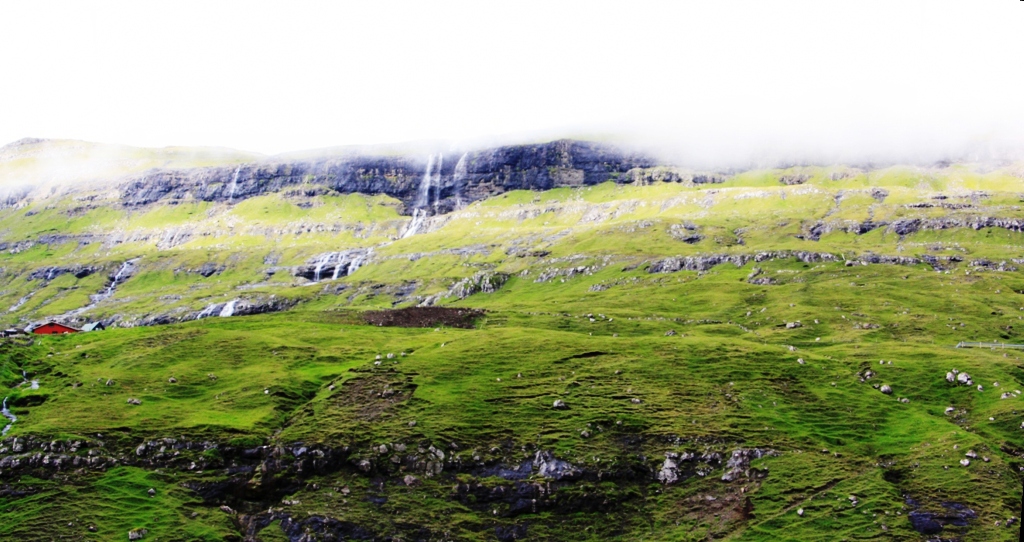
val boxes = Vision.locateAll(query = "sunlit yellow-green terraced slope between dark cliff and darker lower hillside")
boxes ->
[0,162,1024,325]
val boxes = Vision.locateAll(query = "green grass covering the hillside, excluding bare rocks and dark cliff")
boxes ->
[0,158,1024,541]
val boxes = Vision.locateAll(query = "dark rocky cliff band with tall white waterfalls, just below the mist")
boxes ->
[121,140,654,214]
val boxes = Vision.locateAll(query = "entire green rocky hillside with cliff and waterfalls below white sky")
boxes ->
[0,139,1024,542]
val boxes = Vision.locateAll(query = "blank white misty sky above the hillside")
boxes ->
[0,0,1024,162]
